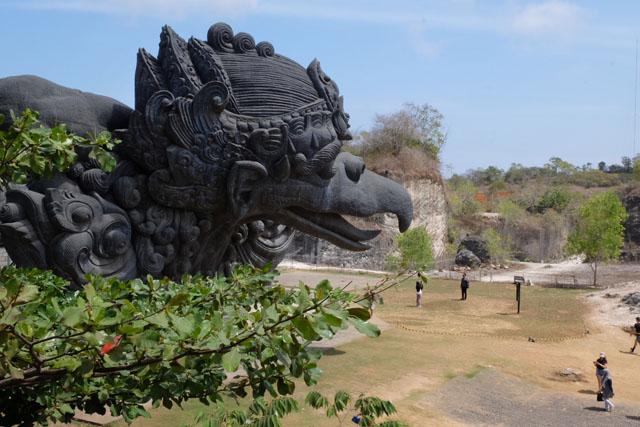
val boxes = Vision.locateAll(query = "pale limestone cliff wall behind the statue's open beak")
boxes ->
[286,179,447,270]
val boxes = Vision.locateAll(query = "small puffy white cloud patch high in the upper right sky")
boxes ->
[512,0,586,38]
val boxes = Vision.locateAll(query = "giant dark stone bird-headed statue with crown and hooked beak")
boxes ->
[0,23,412,285]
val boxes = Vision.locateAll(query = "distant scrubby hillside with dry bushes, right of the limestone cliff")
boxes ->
[445,157,640,262]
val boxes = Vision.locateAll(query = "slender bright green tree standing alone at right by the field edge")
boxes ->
[566,191,627,285]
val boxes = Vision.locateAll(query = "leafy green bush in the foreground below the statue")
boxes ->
[0,267,408,425]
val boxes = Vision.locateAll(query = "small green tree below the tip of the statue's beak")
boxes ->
[387,227,435,271]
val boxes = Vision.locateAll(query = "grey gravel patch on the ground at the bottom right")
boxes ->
[418,369,640,427]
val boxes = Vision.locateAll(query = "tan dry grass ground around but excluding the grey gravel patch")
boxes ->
[97,274,640,426]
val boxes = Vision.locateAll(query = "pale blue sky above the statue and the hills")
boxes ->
[0,0,640,175]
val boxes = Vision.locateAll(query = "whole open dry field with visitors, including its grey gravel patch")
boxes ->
[89,272,640,426]
